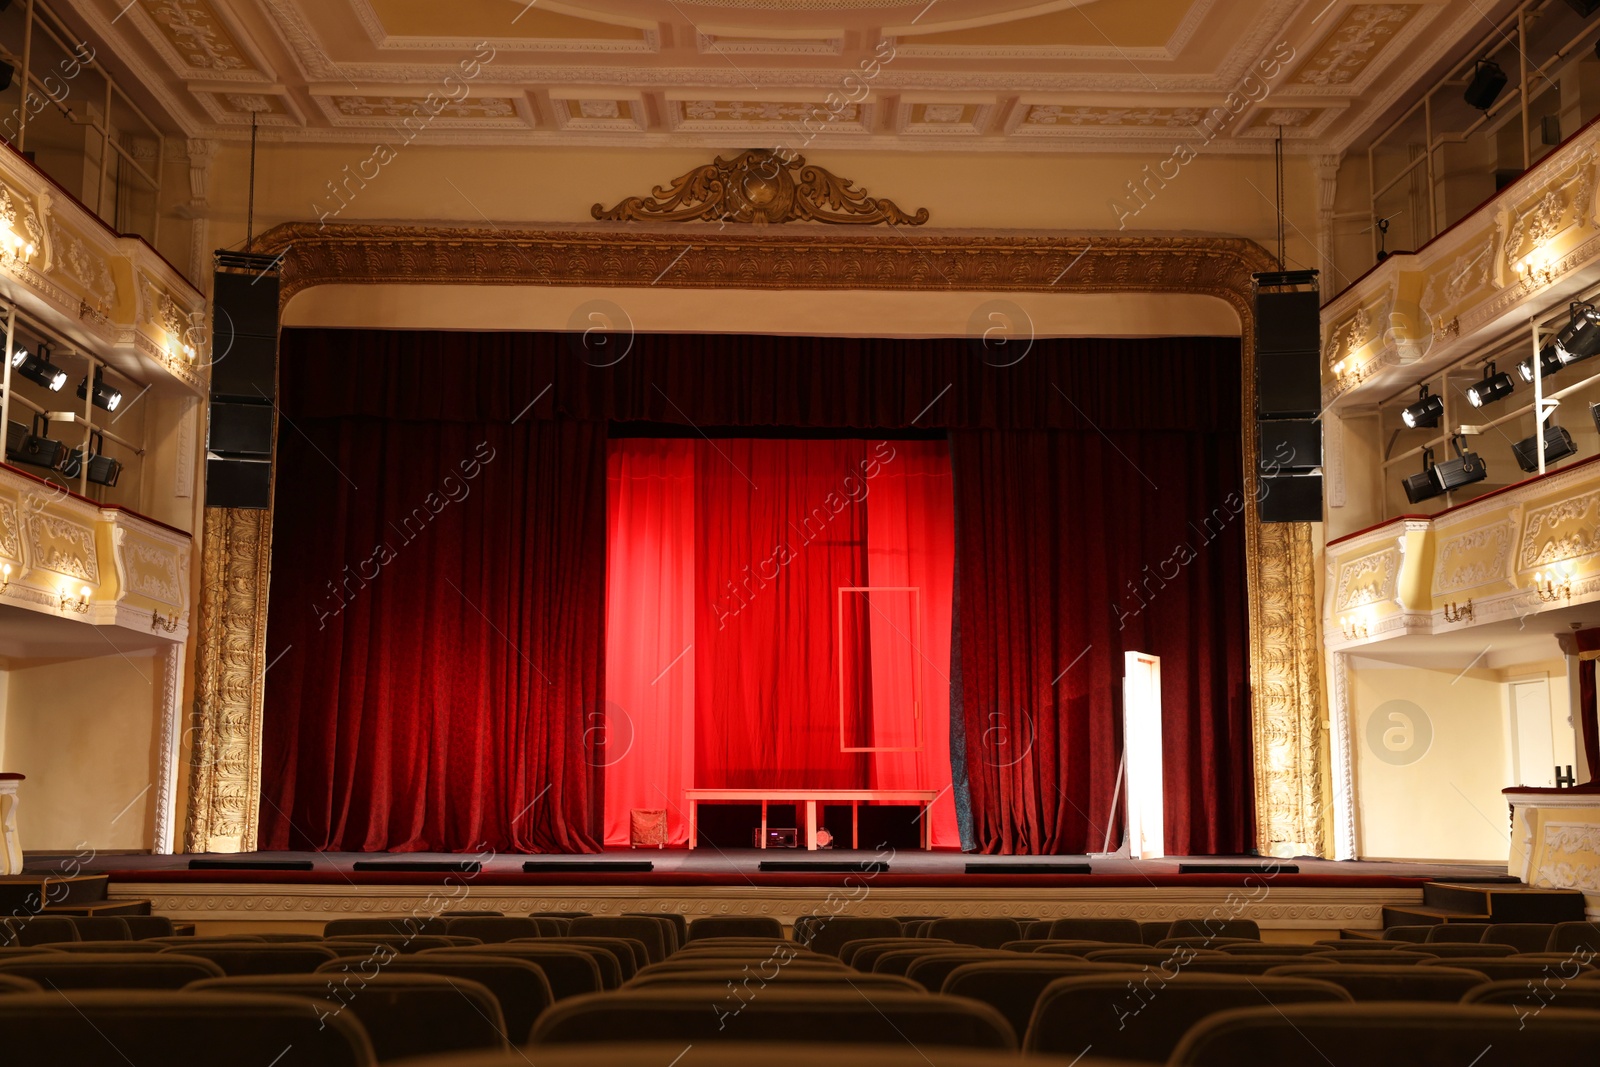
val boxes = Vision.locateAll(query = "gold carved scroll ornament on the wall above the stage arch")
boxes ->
[590,149,928,226]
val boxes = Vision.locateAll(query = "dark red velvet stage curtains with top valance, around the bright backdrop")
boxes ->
[262,330,1253,853]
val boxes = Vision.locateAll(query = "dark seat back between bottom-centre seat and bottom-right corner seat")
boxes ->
[1022,973,1350,1067]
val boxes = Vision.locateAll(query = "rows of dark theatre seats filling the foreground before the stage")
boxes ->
[0,913,1600,1067]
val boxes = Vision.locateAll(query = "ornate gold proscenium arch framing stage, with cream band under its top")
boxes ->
[187,222,1326,856]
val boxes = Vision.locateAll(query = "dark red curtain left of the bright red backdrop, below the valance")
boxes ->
[261,412,606,853]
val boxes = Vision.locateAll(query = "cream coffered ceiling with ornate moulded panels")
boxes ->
[58,0,1510,152]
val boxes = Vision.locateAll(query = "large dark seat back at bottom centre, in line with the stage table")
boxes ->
[531,985,1016,1059]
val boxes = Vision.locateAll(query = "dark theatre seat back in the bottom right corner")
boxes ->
[1171,1003,1600,1067]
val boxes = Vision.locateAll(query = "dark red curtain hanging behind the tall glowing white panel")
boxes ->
[952,428,1254,856]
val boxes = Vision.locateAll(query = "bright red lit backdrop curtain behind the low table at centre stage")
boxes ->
[605,438,958,846]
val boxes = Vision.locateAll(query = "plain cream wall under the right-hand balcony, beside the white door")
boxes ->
[1349,656,1509,864]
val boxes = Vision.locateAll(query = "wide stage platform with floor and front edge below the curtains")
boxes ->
[27,849,1506,941]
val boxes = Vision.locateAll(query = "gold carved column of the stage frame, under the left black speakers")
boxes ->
[186,507,272,853]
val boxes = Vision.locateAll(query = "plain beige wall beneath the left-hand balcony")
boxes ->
[0,651,162,853]
